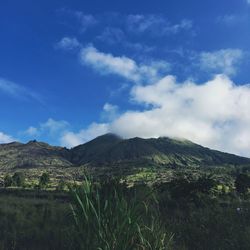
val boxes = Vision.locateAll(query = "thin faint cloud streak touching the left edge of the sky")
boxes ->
[0,78,42,103]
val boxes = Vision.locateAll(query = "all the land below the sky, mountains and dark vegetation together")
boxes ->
[0,134,250,250]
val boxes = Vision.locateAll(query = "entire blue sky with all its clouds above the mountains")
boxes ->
[0,0,250,157]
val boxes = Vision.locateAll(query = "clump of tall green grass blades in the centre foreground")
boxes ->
[71,178,172,250]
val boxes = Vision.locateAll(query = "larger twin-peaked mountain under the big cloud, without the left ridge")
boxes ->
[71,134,250,167]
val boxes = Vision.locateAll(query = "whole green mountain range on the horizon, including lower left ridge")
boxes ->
[0,134,250,169]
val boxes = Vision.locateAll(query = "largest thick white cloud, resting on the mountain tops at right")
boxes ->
[61,75,250,156]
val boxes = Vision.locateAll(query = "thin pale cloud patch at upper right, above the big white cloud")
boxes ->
[199,49,243,75]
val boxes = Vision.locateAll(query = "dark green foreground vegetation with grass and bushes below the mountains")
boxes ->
[0,168,250,250]
